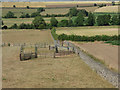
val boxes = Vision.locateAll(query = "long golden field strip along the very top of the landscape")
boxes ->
[2,1,111,7]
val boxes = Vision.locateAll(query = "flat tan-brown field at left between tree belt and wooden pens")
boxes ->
[2,29,53,44]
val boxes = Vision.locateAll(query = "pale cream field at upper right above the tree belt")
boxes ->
[94,6,120,13]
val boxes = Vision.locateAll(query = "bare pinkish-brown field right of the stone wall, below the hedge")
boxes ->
[72,42,119,70]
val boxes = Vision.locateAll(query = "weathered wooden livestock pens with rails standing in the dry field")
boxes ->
[20,43,74,61]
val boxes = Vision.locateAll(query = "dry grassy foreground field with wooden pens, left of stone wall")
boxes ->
[2,47,114,88]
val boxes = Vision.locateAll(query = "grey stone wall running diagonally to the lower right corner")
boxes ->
[66,42,120,88]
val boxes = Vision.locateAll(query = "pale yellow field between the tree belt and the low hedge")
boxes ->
[56,26,118,36]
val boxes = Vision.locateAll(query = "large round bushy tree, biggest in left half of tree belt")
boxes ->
[32,16,46,29]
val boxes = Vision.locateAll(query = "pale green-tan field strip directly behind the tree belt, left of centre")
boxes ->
[2,17,68,27]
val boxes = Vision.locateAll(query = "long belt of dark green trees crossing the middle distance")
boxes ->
[2,8,120,29]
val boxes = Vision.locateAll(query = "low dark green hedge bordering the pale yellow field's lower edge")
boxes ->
[58,34,120,42]
